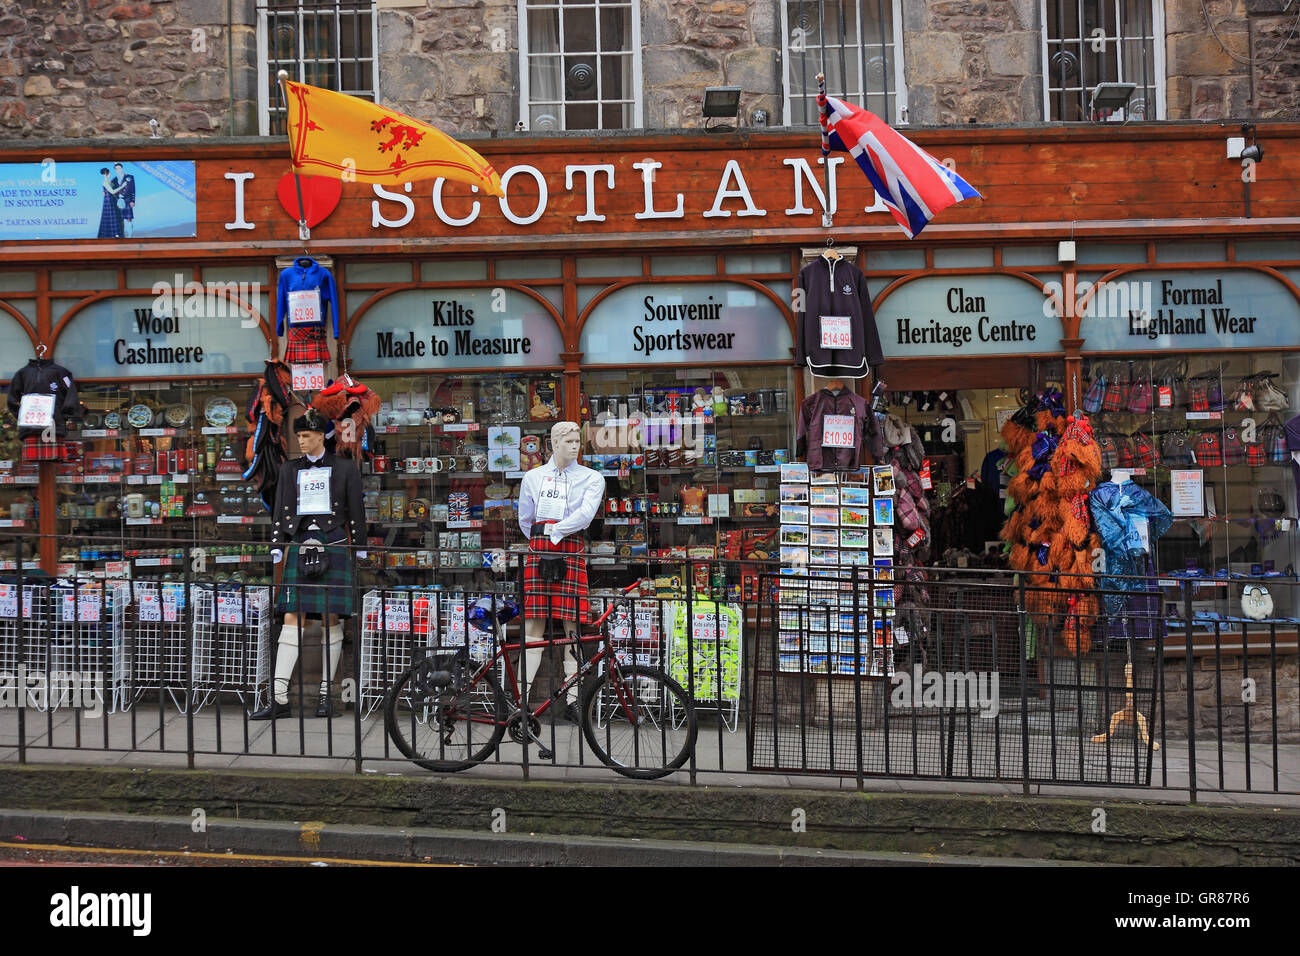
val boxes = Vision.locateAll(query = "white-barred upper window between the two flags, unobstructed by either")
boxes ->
[519,0,641,133]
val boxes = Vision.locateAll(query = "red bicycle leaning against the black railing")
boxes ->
[384,584,698,780]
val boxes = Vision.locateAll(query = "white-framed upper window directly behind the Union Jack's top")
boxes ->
[781,0,907,126]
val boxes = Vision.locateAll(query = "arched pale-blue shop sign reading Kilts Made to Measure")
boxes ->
[348,289,564,372]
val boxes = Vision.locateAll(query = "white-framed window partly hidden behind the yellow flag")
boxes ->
[257,0,380,137]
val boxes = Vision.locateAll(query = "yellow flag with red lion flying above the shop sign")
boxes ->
[285,79,504,196]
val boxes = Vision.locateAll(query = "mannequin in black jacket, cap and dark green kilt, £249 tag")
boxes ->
[252,410,365,721]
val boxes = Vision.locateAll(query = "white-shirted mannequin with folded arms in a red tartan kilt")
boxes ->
[519,421,605,722]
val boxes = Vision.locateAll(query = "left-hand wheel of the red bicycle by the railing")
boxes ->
[384,665,506,773]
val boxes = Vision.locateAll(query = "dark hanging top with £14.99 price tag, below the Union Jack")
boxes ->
[794,256,883,378]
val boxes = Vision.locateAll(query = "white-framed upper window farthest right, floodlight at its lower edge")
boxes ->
[1040,0,1165,122]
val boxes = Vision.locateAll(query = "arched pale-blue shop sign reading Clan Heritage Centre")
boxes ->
[875,276,1062,359]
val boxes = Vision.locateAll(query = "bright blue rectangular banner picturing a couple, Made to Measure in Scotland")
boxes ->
[0,159,198,239]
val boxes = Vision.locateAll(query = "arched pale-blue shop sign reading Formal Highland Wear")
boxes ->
[1080,269,1300,352]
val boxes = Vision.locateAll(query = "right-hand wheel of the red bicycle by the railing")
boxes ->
[580,666,698,780]
